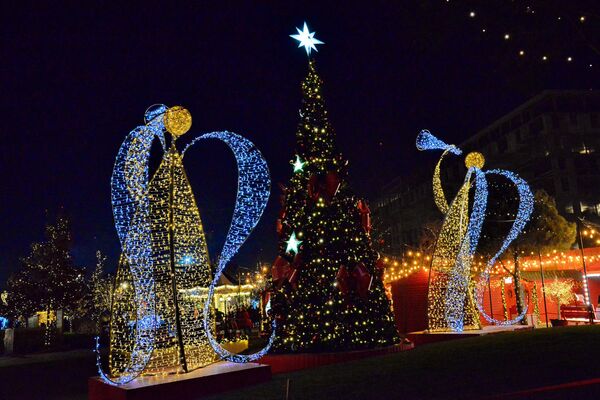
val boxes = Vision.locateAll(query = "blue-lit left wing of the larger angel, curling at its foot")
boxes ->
[96,105,166,384]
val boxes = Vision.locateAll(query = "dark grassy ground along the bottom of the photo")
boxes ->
[0,326,600,400]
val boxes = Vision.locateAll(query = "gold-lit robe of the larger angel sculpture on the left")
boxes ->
[109,143,216,376]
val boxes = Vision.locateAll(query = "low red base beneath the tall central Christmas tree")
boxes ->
[259,343,414,374]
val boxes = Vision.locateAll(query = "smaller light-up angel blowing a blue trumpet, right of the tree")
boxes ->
[417,130,533,332]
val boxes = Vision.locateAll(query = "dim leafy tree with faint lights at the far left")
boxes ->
[7,216,85,345]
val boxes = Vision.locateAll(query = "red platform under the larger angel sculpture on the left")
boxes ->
[88,361,271,400]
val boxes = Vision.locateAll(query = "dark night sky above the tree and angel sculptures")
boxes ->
[0,0,600,286]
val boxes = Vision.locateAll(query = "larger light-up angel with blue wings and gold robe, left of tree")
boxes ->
[96,105,274,384]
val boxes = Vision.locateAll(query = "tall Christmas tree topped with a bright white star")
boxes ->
[272,24,398,352]
